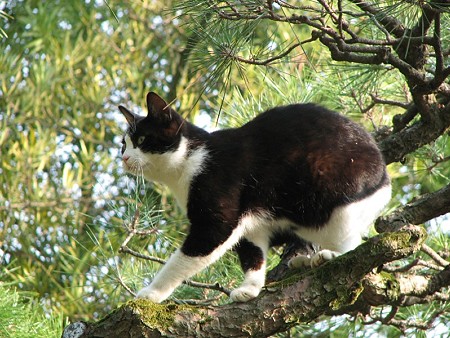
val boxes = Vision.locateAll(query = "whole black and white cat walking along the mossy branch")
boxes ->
[119,92,391,303]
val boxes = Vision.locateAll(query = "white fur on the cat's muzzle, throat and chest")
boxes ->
[122,135,208,210]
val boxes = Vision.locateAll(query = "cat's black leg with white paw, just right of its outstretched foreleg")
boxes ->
[230,236,269,302]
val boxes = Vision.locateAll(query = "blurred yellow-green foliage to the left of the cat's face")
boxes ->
[0,0,200,318]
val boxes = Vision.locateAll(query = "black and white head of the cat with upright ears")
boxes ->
[119,92,184,180]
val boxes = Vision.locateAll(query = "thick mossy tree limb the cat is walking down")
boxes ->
[63,226,425,338]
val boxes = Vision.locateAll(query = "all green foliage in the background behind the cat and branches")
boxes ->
[0,0,450,337]
